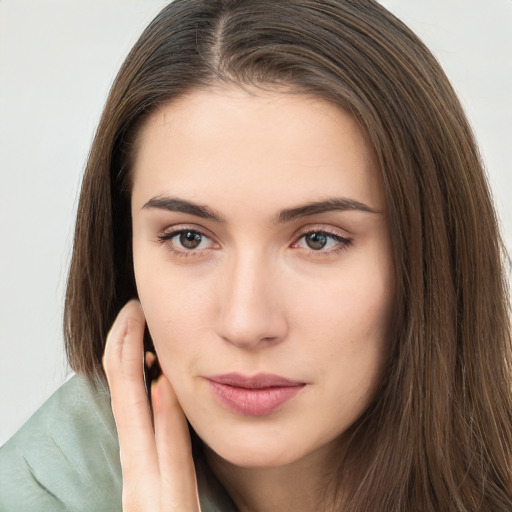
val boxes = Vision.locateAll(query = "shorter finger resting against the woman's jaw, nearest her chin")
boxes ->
[152,375,200,512]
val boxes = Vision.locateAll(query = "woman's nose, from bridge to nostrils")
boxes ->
[217,252,288,349]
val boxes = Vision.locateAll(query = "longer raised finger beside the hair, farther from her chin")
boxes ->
[103,301,159,510]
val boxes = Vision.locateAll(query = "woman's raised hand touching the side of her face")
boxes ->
[103,300,200,512]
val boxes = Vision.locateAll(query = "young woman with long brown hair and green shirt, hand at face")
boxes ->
[0,0,512,512]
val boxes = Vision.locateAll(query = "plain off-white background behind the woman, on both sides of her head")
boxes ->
[0,0,512,444]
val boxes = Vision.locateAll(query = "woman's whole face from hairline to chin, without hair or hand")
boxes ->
[132,87,393,467]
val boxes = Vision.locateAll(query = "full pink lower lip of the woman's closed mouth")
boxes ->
[208,380,305,416]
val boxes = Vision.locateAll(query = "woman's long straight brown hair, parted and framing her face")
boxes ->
[65,0,512,512]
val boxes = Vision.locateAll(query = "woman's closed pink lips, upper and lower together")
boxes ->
[206,373,306,416]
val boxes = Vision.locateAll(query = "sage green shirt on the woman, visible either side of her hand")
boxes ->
[0,375,236,512]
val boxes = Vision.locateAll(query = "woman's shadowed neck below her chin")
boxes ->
[205,436,342,512]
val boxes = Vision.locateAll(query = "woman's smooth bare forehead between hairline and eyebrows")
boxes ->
[132,87,382,209]
